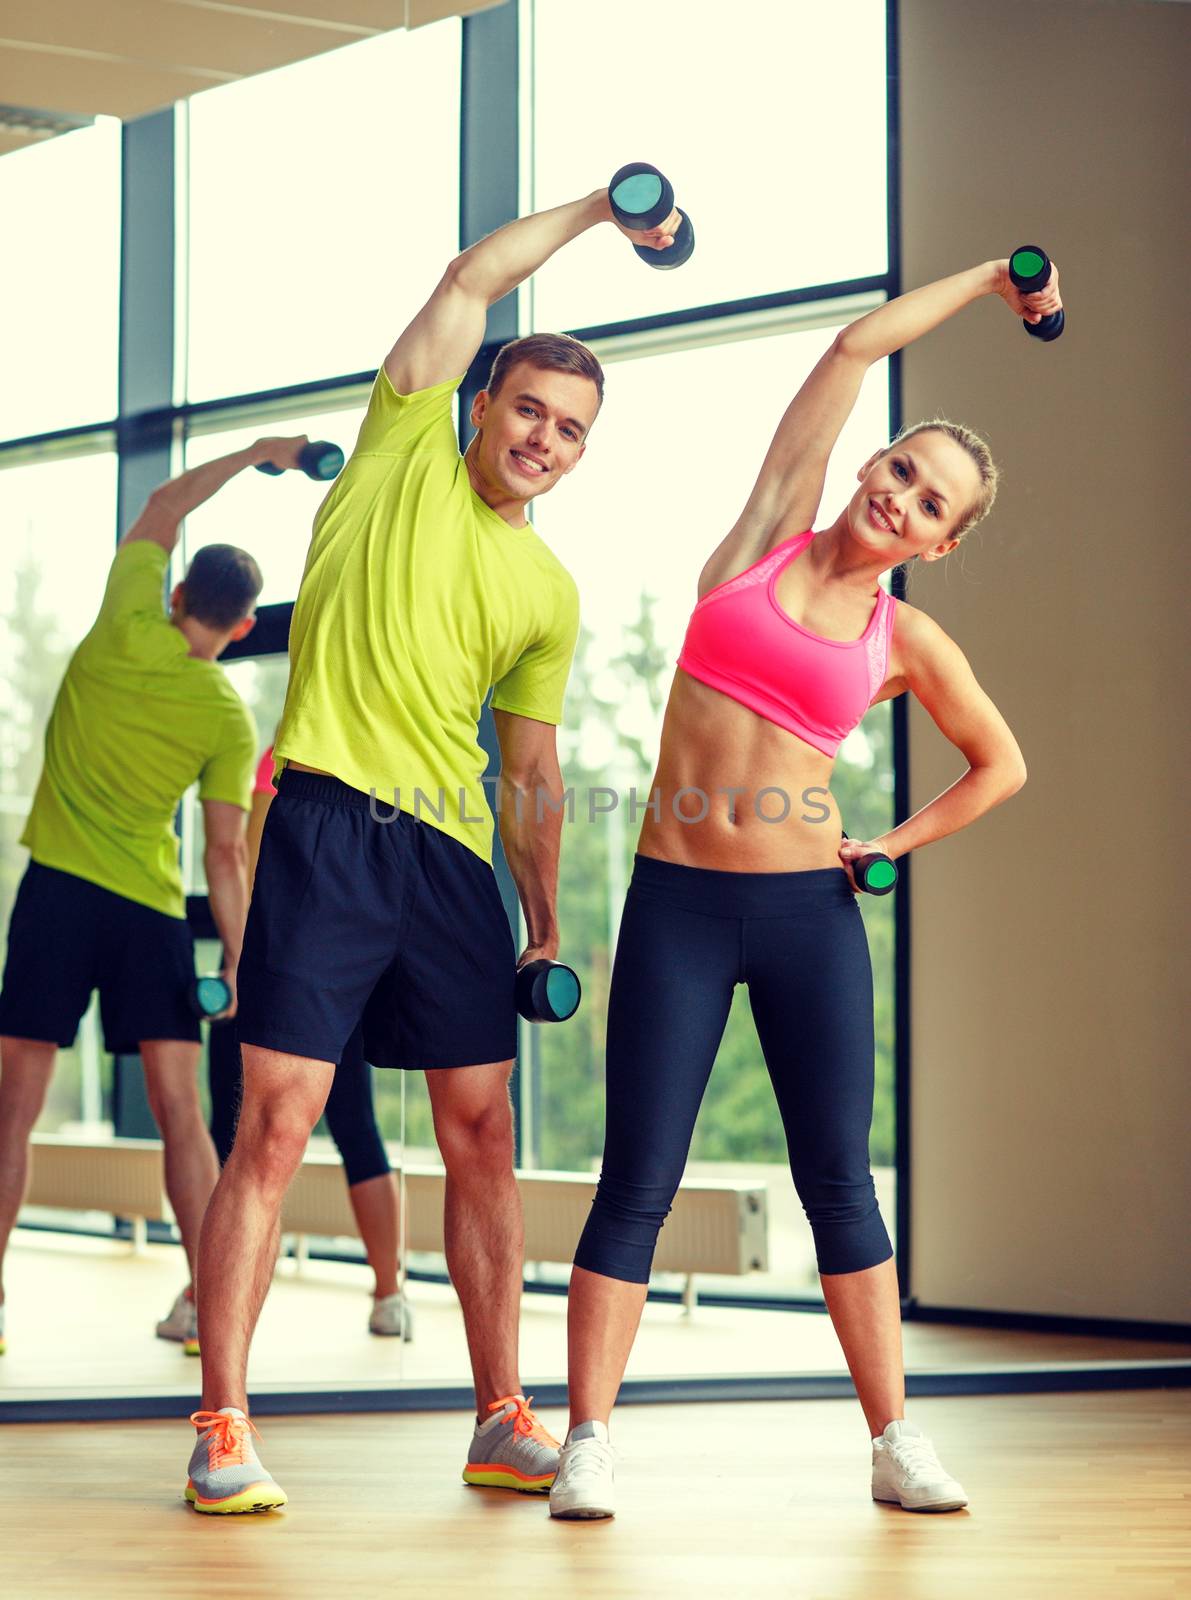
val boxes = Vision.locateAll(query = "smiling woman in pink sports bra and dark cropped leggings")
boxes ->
[551,261,1061,1517]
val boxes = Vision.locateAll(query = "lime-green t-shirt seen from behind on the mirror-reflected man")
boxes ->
[21,539,256,917]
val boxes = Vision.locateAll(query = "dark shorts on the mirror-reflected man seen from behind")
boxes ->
[0,861,200,1054]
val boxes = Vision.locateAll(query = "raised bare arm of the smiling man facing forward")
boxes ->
[384,189,679,395]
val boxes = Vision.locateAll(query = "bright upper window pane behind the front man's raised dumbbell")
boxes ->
[523,0,887,328]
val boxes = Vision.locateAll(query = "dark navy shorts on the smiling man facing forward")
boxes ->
[237,770,517,1070]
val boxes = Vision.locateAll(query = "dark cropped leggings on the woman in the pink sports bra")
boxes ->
[575,856,893,1283]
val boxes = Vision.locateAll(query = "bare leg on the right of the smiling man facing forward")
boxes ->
[426,1061,525,1422]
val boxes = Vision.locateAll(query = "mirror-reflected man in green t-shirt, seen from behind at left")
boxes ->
[0,438,306,1349]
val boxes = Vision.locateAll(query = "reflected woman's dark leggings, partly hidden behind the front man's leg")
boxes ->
[207,1022,391,1184]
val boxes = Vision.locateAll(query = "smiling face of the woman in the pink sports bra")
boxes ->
[848,432,980,565]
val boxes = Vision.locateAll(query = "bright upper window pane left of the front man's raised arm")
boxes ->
[187,21,459,400]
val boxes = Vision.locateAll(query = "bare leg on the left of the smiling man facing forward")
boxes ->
[195,1045,335,1413]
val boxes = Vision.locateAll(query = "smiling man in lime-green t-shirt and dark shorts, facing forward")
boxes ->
[186,190,688,1512]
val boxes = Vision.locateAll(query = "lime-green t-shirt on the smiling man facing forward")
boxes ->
[275,368,579,861]
